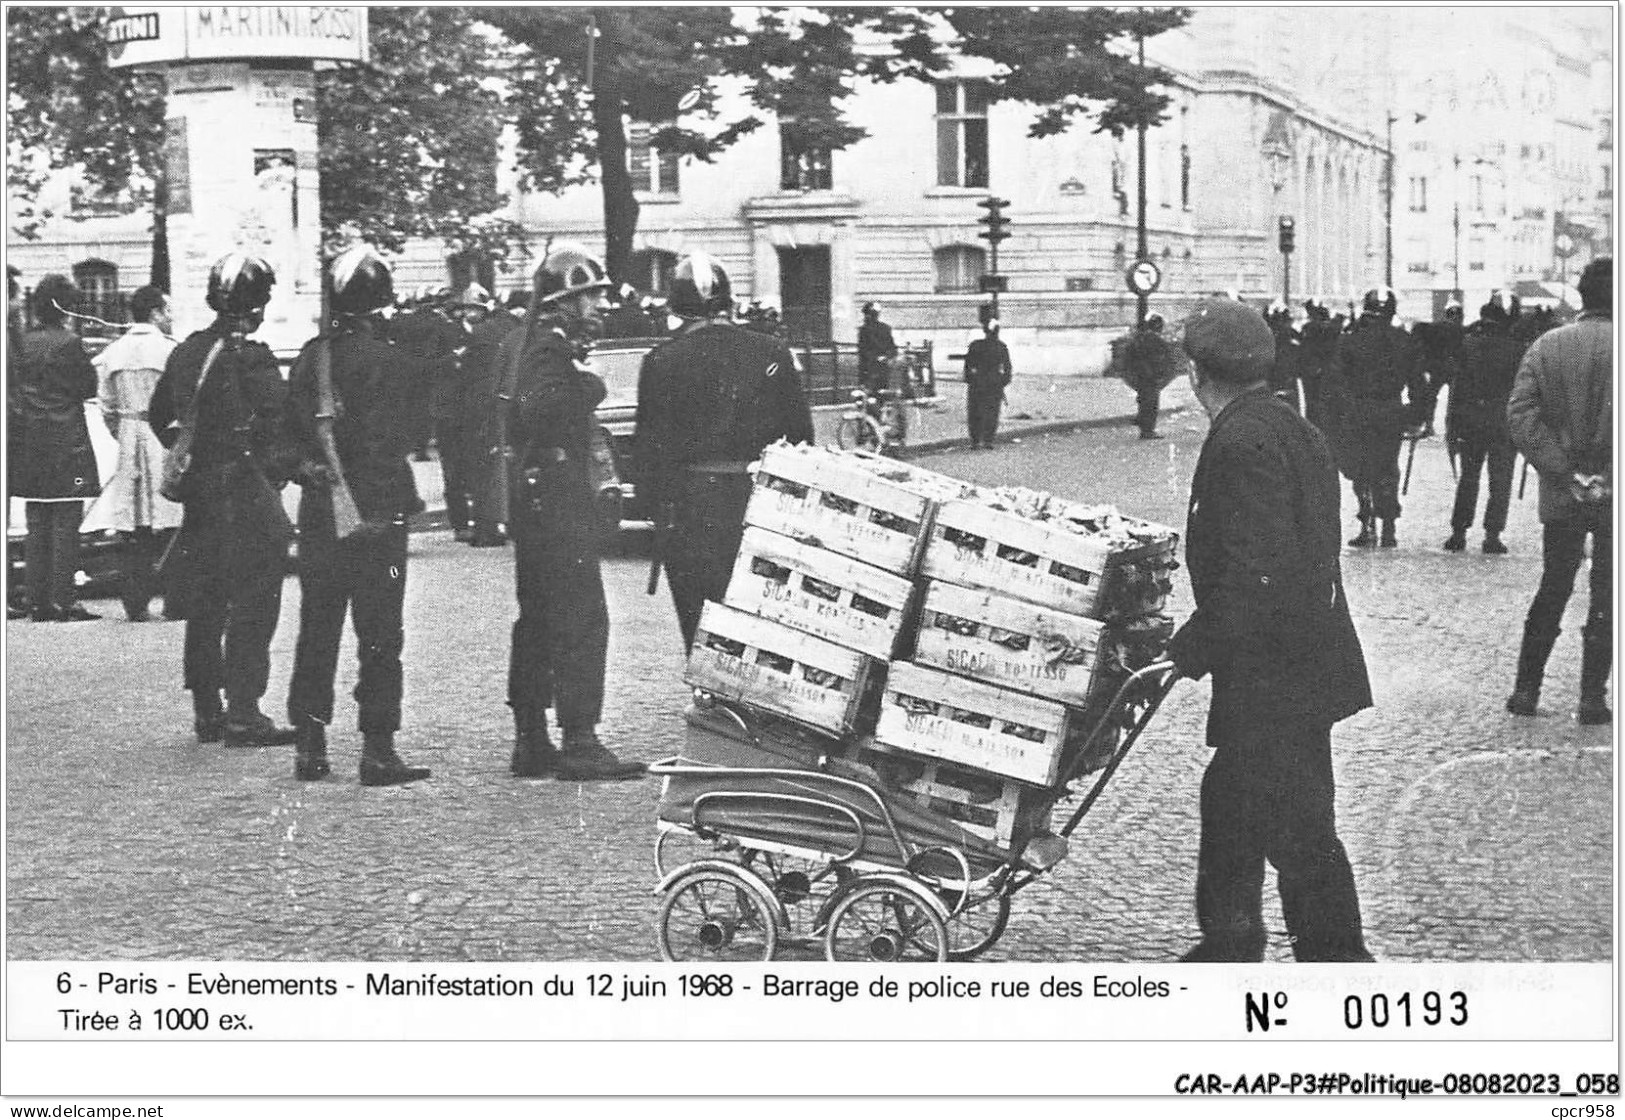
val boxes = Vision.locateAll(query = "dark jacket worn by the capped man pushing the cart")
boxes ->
[1175,387,1372,727]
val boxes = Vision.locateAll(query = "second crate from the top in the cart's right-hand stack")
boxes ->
[913,582,1110,705]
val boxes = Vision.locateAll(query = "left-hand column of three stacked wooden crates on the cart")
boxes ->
[684,444,967,738]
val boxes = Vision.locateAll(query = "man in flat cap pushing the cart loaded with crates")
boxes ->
[1168,299,1372,961]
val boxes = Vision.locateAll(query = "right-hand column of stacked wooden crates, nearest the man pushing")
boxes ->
[874,491,1177,847]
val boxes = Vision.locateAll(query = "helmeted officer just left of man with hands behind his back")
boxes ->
[1445,299,1524,556]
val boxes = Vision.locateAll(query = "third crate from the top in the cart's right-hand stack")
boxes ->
[874,662,1073,787]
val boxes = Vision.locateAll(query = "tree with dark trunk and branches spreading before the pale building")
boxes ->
[479,7,1190,280]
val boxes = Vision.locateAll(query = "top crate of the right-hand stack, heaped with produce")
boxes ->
[921,499,1178,618]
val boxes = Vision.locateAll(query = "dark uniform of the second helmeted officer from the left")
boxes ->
[288,319,427,751]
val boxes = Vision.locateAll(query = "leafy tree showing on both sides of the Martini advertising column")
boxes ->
[7,7,522,288]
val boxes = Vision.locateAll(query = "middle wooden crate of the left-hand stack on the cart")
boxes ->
[723,527,913,662]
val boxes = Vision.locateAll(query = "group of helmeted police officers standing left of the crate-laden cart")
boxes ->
[150,245,813,785]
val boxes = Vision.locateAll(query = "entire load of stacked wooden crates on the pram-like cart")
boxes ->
[686,444,1175,847]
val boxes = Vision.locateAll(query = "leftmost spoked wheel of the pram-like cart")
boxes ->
[657,868,778,961]
